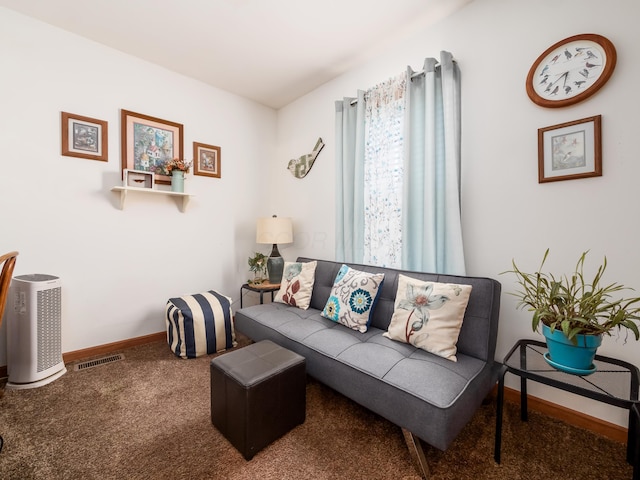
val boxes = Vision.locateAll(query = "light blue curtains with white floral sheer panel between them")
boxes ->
[336,52,465,275]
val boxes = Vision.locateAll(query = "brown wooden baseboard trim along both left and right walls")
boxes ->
[0,332,627,443]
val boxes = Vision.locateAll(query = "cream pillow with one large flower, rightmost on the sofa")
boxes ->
[383,274,471,362]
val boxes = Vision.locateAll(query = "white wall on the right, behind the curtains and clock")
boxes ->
[270,0,640,425]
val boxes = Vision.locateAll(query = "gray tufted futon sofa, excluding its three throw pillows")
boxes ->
[235,258,501,472]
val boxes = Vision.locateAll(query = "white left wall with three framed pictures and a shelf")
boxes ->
[0,8,276,365]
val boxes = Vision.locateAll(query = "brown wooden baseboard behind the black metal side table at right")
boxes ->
[495,387,627,443]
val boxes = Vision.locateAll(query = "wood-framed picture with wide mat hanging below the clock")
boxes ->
[538,115,602,183]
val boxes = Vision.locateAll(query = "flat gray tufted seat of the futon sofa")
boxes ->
[236,303,485,411]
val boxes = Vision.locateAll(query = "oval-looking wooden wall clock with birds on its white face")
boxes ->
[527,33,616,108]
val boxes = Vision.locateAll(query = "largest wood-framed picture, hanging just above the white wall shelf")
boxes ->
[120,110,183,185]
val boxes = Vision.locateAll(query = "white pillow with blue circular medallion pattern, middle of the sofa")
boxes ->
[321,265,384,333]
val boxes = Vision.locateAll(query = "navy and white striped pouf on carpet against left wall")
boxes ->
[165,290,236,358]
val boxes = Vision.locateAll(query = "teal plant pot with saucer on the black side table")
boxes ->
[542,325,602,375]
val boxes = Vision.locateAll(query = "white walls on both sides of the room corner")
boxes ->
[5,0,640,425]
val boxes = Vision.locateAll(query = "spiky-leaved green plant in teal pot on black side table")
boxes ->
[503,249,640,375]
